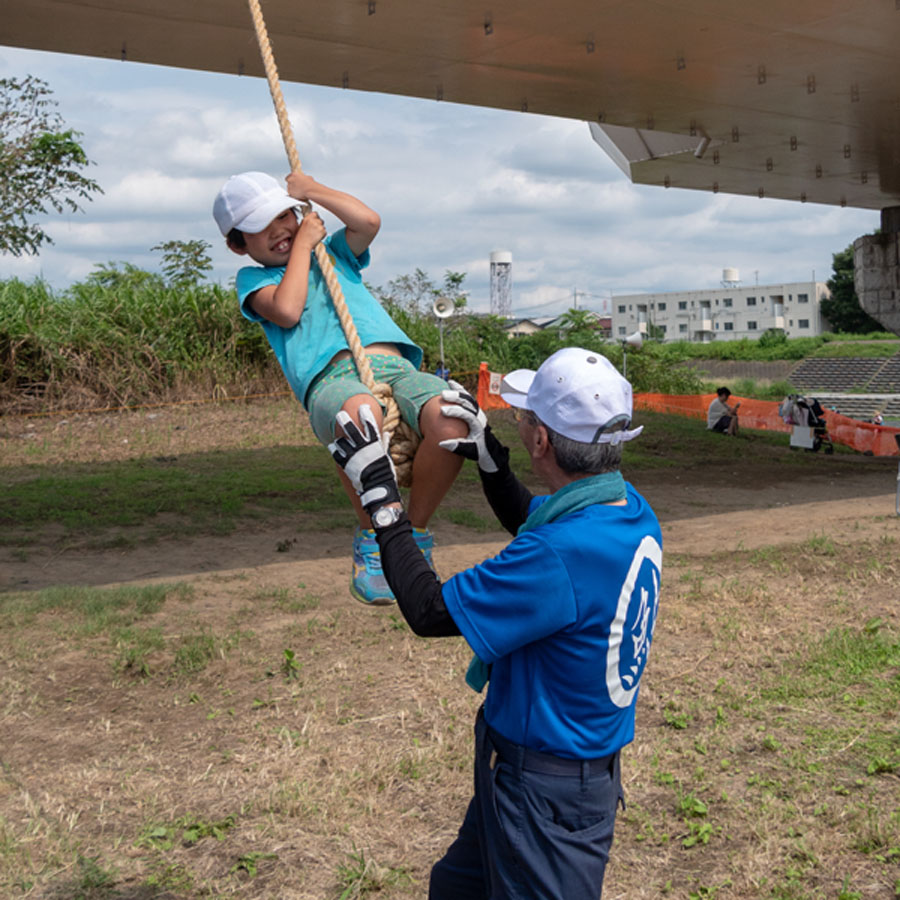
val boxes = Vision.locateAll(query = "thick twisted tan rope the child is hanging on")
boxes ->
[247,0,419,487]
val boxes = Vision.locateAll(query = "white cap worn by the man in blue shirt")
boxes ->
[500,347,644,444]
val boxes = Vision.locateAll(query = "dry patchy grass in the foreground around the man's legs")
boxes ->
[0,533,900,900]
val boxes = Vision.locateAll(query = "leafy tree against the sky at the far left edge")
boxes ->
[0,75,102,256]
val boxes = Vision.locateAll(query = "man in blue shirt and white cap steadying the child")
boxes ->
[330,348,662,900]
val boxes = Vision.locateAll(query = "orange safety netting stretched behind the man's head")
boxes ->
[478,363,900,456]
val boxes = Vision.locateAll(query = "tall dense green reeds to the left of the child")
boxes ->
[0,269,274,410]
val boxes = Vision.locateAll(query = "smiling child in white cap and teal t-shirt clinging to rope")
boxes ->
[213,172,465,604]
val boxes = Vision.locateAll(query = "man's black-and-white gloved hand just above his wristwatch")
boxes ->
[328,403,401,516]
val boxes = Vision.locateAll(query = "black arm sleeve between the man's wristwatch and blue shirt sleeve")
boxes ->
[375,514,460,637]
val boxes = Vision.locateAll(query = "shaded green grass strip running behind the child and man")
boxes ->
[0,411,872,556]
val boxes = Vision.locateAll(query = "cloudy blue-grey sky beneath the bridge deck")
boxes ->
[0,46,879,316]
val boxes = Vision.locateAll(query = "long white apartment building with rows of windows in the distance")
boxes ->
[611,269,831,343]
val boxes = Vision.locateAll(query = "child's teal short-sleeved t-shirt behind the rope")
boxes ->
[236,228,422,407]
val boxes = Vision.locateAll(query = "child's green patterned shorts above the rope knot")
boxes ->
[306,354,447,444]
